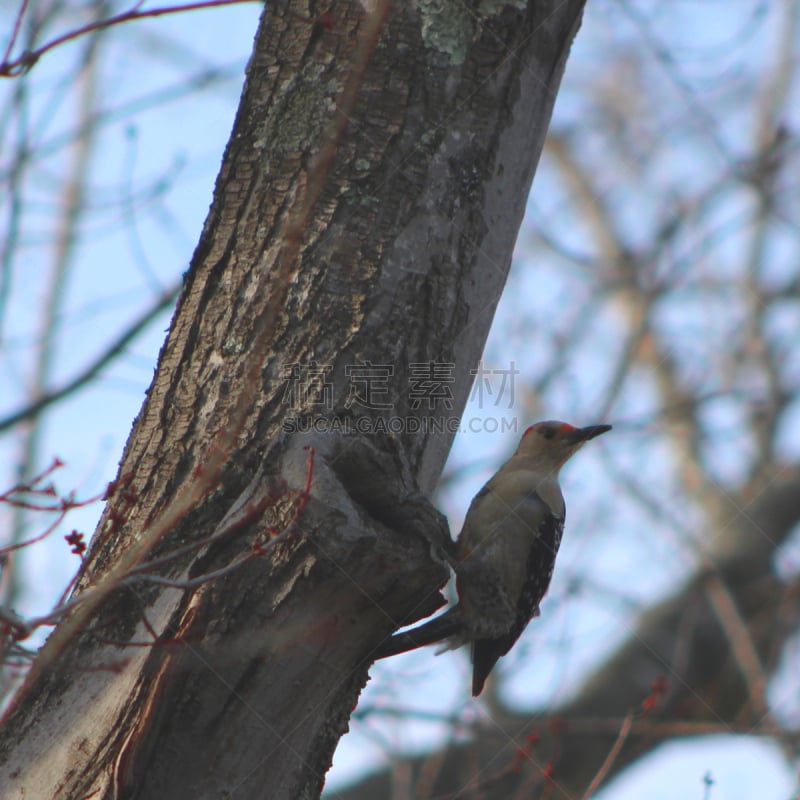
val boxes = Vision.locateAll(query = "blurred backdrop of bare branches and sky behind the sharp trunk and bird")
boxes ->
[0,0,800,800]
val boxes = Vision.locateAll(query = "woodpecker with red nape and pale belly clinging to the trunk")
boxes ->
[377,420,611,696]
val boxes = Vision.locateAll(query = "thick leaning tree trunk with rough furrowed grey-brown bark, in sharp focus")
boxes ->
[0,0,583,800]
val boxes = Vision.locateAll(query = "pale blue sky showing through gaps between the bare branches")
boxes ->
[0,0,800,800]
